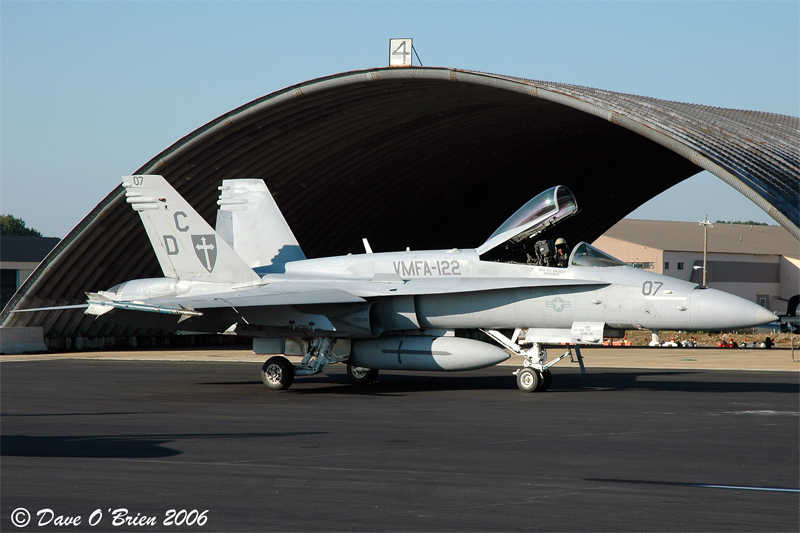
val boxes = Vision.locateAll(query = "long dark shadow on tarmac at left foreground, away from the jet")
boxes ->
[0,431,324,459]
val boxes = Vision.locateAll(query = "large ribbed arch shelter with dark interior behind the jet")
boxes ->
[0,68,800,337]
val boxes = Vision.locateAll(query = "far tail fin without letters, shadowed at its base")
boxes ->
[217,179,306,272]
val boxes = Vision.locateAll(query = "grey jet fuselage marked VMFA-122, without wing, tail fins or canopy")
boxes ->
[264,250,772,331]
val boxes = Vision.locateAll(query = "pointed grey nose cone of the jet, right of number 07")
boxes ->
[690,289,778,331]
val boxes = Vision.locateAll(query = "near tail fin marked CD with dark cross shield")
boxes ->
[122,175,260,283]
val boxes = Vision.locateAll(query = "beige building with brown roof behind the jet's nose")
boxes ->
[592,218,800,314]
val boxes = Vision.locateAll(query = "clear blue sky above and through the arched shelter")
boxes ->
[0,0,800,237]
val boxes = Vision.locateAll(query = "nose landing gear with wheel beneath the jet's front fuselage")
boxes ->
[481,329,586,392]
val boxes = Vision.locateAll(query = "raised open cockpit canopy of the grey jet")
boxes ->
[477,185,578,255]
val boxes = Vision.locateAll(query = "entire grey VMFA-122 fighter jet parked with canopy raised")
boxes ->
[21,175,777,392]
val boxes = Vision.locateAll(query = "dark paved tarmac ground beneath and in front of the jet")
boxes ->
[0,350,800,531]
